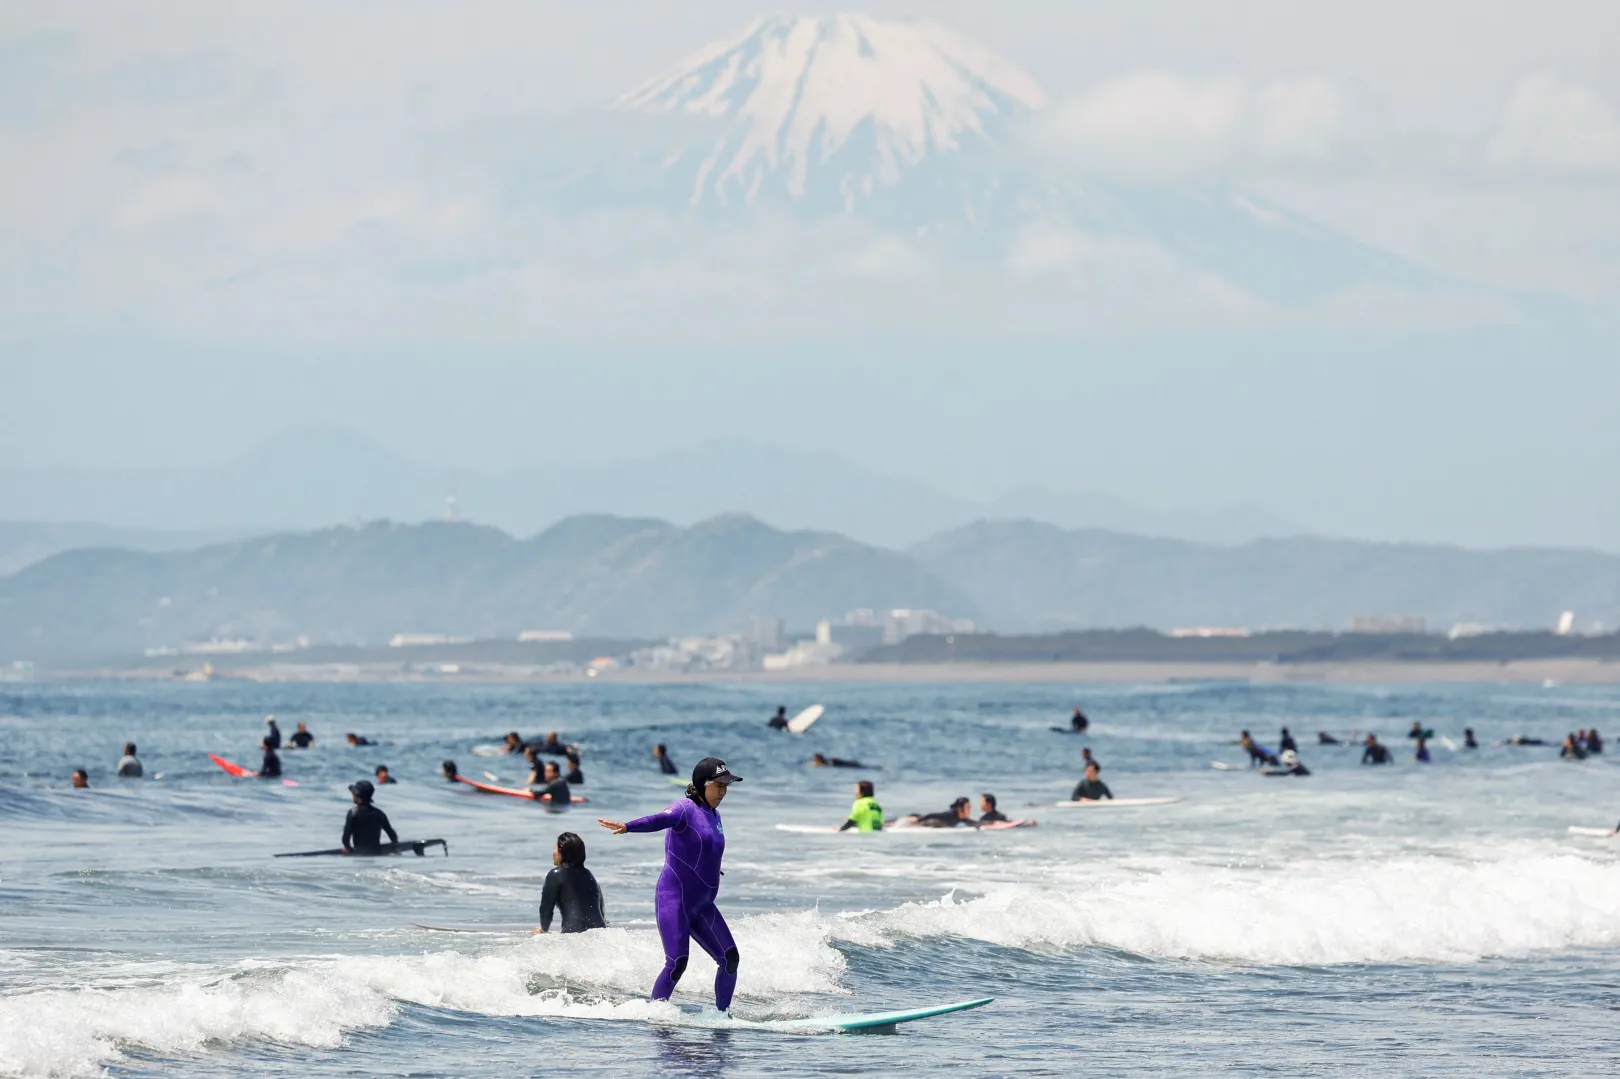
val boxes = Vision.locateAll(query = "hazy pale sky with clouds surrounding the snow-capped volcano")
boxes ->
[0,0,1620,548]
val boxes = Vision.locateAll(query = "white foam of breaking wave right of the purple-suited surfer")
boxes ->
[839,854,1620,966]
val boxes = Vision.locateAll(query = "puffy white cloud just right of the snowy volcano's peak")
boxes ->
[1042,71,1362,180]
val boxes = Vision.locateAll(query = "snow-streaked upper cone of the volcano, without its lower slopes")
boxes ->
[620,15,1045,207]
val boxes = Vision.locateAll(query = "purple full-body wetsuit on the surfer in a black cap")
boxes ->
[625,799,740,1011]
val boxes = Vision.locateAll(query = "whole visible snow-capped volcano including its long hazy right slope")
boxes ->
[546,15,1440,306]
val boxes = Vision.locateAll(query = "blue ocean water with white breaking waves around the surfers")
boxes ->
[0,684,1620,1077]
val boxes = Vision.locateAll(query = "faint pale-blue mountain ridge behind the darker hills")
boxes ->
[0,426,1299,557]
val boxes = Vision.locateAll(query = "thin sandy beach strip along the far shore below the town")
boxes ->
[44,659,1620,685]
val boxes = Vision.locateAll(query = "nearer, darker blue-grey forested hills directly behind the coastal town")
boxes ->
[0,515,1620,661]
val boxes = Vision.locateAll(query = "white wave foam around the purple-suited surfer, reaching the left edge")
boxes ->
[0,911,844,1076]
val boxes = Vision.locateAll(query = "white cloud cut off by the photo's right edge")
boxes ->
[1487,73,1620,177]
